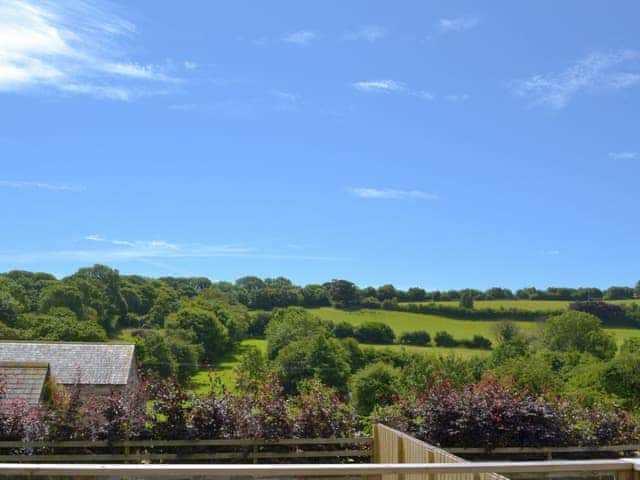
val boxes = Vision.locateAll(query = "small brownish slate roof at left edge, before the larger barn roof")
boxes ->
[0,362,49,404]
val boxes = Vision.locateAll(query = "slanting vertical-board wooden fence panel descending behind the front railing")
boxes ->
[372,424,508,480]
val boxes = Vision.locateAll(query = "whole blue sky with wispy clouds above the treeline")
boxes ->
[0,0,640,289]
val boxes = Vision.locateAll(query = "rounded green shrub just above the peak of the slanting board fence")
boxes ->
[351,362,400,415]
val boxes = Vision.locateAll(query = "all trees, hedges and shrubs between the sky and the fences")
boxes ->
[0,265,640,448]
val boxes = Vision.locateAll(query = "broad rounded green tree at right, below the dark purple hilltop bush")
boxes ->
[542,311,616,360]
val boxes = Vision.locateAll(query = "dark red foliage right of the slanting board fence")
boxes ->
[377,380,638,450]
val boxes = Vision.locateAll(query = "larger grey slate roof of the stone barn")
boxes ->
[0,342,134,385]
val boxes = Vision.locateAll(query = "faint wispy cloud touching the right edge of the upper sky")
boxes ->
[515,50,640,110]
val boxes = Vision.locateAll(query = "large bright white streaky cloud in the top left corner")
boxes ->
[0,0,190,101]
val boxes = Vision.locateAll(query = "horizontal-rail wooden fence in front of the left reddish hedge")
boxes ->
[0,437,372,463]
